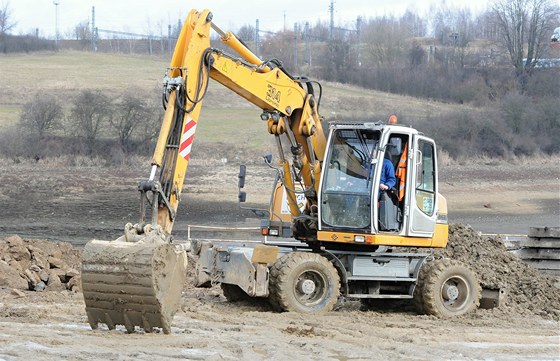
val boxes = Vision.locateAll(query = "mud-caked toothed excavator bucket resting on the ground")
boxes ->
[82,226,187,334]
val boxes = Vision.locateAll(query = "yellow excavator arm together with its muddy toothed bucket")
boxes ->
[82,10,326,333]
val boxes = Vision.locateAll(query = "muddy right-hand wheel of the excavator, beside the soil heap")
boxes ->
[414,259,481,318]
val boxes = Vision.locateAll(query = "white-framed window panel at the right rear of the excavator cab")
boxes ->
[408,135,438,237]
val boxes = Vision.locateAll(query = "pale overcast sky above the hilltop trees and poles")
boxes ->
[7,0,489,37]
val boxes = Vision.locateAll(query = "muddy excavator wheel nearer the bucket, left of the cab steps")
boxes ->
[269,252,340,313]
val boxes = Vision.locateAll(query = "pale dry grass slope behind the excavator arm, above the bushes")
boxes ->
[0,51,476,147]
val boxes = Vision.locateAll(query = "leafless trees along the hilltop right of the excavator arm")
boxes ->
[233,0,560,100]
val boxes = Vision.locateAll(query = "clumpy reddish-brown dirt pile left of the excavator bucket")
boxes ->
[0,236,81,292]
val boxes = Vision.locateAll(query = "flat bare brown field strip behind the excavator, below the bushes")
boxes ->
[0,154,560,245]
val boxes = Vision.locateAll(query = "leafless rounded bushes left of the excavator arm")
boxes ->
[0,90,161,159]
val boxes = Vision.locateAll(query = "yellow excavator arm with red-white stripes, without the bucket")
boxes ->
[153,10,326,233]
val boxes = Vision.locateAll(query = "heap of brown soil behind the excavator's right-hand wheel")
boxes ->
[434,224,560,320]
